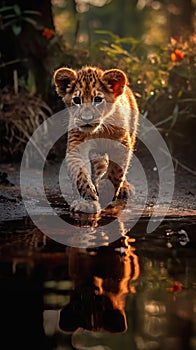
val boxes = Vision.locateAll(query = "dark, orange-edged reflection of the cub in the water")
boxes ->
[59,216,140,333]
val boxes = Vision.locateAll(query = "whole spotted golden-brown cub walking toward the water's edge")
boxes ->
[54,66,139,213]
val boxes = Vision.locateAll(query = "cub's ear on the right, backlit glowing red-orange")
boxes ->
[102,69,128,97]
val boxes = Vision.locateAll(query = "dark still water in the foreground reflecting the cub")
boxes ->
[0,217,196,350]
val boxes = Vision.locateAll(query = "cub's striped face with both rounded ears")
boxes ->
[54,67,127,133]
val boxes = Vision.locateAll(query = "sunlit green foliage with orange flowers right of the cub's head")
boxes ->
[94,31,196,143]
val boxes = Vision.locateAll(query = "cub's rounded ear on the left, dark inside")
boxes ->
[53,68,77,97]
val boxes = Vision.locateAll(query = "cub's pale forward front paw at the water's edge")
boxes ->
[70,199,101,214]
